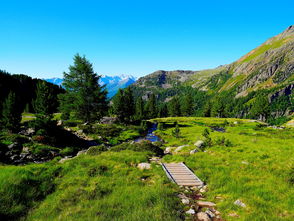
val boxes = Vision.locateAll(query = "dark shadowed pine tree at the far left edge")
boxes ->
[2,92,22,132]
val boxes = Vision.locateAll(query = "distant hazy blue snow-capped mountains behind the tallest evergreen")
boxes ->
[44,75,137,98]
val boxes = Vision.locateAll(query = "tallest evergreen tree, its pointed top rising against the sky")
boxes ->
[60,54,107,122]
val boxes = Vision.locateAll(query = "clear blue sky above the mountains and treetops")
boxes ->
[0,0,294,78]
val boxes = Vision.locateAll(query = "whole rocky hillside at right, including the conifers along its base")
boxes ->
[132,26,294,123]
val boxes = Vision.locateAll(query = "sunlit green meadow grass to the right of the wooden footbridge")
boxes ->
[155,118,294,220]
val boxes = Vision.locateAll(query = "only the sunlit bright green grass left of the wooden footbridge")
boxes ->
[28,151,181,220]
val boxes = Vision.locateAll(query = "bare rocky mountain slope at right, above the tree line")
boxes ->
[133,25,294,118]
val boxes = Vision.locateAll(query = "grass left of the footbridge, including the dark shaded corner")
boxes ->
[0,150,182,221]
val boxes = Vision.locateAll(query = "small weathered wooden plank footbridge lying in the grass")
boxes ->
[162,163,203,187]
